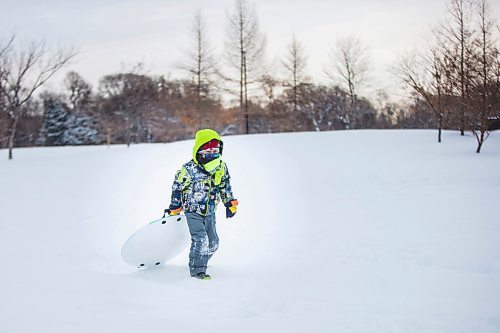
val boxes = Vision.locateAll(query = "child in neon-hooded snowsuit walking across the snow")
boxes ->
[166,129,238,280]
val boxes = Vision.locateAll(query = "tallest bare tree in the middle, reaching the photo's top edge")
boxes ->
[226,0,265,134]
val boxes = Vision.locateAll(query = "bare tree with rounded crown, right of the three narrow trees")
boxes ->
[326,36,369,126]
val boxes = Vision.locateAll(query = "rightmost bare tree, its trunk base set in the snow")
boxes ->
[468,0,500,153]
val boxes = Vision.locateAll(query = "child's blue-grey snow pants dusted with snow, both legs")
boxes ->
[186,213,219,276]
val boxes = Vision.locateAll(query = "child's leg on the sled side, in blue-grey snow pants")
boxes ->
[186,213,210,276]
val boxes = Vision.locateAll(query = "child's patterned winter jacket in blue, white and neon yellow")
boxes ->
[169,160,234,216]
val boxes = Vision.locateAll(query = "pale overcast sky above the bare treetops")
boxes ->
[0,0,500,101]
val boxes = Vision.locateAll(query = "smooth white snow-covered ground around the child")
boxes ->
[0,131,500,333]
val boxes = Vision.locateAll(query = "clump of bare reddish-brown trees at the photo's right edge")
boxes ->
[398,0,500,153]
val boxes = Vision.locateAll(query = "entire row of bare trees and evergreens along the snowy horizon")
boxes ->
[0,0,500,158]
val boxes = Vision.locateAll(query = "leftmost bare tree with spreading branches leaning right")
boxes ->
[0,37,76,159]
